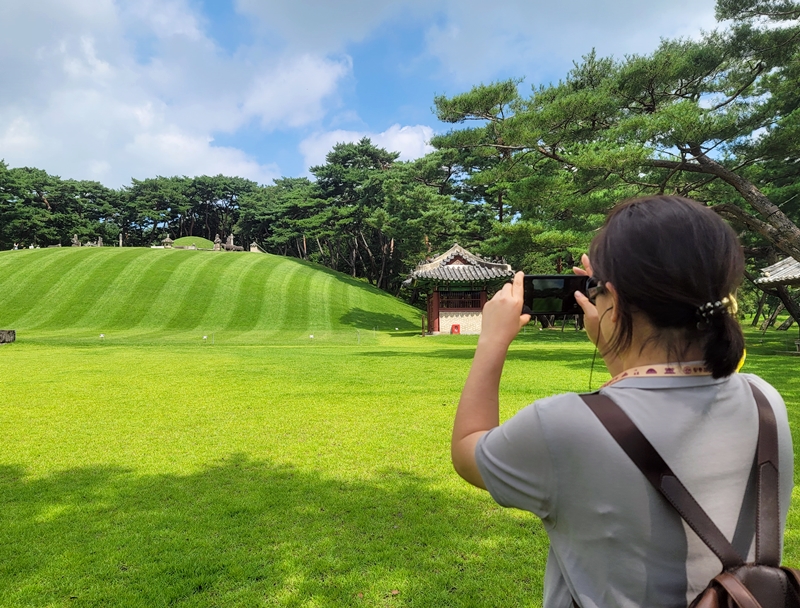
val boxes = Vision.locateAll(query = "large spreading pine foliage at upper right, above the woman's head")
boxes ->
[432,0,800,298]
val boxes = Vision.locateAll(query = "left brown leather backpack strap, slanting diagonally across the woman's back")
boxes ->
[581,393,744,569]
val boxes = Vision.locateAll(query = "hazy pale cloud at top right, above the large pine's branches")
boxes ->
[426,0,715,84]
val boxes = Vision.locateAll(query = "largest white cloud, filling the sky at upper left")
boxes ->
[0,0,352,187]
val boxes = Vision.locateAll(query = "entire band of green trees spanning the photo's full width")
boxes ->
[0,0,800,319]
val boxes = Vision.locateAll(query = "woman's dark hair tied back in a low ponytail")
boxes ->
[589,196,744,378]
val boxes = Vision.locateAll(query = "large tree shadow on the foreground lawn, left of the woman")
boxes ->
[0,456,547,607]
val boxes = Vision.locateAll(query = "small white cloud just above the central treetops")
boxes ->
[300,125,433,169]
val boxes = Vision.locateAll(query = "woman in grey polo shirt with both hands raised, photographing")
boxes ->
[451,196,793,608]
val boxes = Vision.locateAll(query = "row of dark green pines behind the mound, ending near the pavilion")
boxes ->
[0,144,492,293]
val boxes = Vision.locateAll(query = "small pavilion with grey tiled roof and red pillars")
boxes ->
[405,243,514,334]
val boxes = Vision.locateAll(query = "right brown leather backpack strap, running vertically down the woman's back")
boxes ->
[750,384,781,567]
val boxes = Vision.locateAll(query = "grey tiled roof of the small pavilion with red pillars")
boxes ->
[406,243,514,284]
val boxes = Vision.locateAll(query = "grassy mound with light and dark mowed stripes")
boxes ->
[0,247,420,343]
